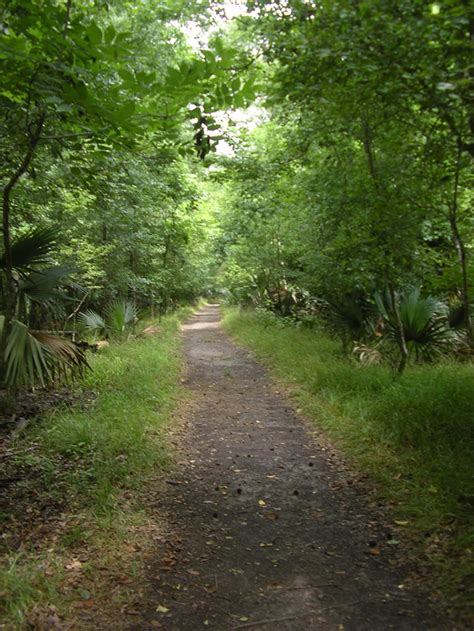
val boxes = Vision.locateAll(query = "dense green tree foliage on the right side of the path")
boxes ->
[216,0,474,358]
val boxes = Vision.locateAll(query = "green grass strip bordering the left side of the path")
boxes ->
[0,309,191,629]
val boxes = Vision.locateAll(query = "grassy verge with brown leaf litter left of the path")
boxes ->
[0,310,191,629]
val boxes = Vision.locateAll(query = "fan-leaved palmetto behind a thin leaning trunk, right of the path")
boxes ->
[375,288,458,361]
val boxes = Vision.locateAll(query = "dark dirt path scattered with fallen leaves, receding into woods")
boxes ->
[133,306,448,631]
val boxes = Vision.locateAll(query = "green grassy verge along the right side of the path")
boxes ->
[224,309,474,620]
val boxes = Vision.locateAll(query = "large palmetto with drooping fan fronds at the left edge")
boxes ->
[0,228,88,389]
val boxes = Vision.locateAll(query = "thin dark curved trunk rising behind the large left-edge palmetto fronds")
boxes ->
[0,112,45,384]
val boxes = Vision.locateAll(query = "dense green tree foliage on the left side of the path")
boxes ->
[0,0,254,385]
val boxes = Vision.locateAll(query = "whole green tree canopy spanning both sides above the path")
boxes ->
[0,0,474,386]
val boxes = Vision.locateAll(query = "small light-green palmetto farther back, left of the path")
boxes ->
[78,300,138,339]
